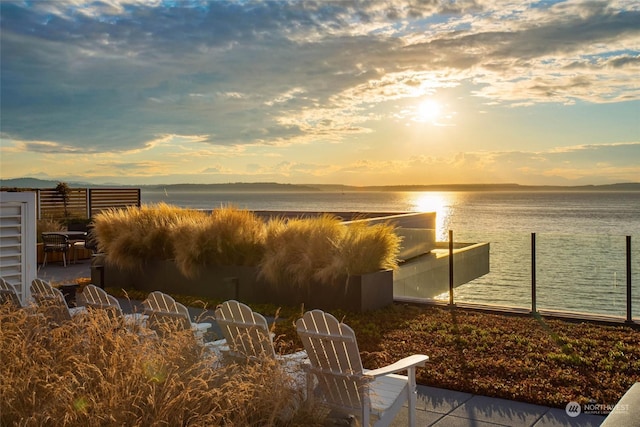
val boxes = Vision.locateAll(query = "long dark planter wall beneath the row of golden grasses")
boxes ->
[97,257,393,312]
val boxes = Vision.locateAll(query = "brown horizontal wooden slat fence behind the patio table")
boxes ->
[37,188,140,220]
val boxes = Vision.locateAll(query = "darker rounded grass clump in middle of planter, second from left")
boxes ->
[173,207,266,277]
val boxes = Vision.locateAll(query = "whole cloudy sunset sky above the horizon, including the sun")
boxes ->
[0,0,640,186]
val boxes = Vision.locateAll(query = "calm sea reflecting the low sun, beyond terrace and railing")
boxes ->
[142,190,640,318]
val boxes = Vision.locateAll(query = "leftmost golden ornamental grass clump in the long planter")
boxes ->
[94,203,207,269]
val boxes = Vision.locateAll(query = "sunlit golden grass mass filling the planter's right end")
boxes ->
[260,215,400,286]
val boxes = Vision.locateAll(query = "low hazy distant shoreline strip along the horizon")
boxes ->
[0,178,640,192]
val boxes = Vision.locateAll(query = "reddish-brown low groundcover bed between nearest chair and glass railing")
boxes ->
[276,304,640,408]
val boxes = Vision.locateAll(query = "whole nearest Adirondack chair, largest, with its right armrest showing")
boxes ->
[296,310,429,427]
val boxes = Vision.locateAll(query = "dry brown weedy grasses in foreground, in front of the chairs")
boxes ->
[0,305,321,426]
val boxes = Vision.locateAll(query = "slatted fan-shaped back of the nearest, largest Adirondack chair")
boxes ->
[296,310,370,410]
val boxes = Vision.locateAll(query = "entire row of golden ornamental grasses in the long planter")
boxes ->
[94,203,401,286]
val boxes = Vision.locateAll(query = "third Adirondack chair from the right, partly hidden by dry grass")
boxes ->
[142,291,211,338]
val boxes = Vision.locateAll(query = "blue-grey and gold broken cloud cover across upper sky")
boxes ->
[0,0,640,187]
